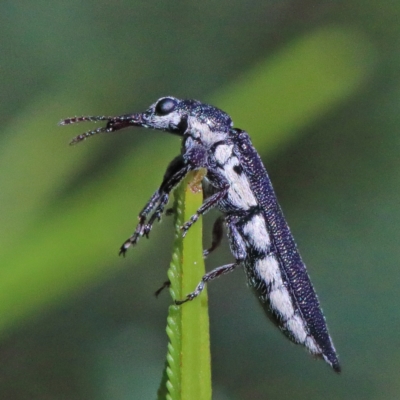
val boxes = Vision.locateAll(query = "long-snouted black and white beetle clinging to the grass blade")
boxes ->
[60,96,340,372]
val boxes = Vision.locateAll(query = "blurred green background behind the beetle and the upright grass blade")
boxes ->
[0,0,400,400]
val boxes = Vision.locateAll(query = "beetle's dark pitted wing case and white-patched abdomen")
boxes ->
[231,130,340,371]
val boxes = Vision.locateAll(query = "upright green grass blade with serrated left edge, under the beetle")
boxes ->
[167,174,211,400]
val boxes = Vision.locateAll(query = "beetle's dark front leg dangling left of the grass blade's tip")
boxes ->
[119,155,189,255]
